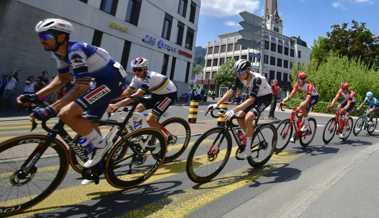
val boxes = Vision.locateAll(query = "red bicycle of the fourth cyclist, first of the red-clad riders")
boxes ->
[275,104,317,154]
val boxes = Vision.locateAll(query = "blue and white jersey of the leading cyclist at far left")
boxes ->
[53,41,126,83]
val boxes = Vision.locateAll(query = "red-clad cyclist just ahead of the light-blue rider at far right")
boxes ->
[328,82,357,137]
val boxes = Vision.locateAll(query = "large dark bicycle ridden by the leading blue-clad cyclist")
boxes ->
[0,98,166,216]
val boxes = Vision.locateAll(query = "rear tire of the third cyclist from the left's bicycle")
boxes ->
[247,124,278,168]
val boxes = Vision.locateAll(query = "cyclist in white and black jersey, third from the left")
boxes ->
[208,59,272,159]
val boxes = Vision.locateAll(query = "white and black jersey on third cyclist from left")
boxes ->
[232,72,272,97]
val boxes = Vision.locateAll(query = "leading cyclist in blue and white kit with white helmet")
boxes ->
[17,18,126,168]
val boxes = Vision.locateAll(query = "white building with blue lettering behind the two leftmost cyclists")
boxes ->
[0,0,201,95]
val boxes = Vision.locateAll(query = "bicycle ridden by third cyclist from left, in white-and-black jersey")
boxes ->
[186,109,277,183]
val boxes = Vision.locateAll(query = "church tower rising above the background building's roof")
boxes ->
[264,0,283,34]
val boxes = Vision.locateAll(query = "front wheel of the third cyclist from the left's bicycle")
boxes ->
[186,127,232,183]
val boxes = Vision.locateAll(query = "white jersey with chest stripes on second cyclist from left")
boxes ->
[129,71,176,95]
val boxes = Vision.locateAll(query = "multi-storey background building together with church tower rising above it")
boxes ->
[199,0,311,92]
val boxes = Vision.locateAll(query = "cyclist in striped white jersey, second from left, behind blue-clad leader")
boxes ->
[108,57,177,141]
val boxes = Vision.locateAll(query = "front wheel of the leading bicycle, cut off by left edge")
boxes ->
[0,135,68,217]
